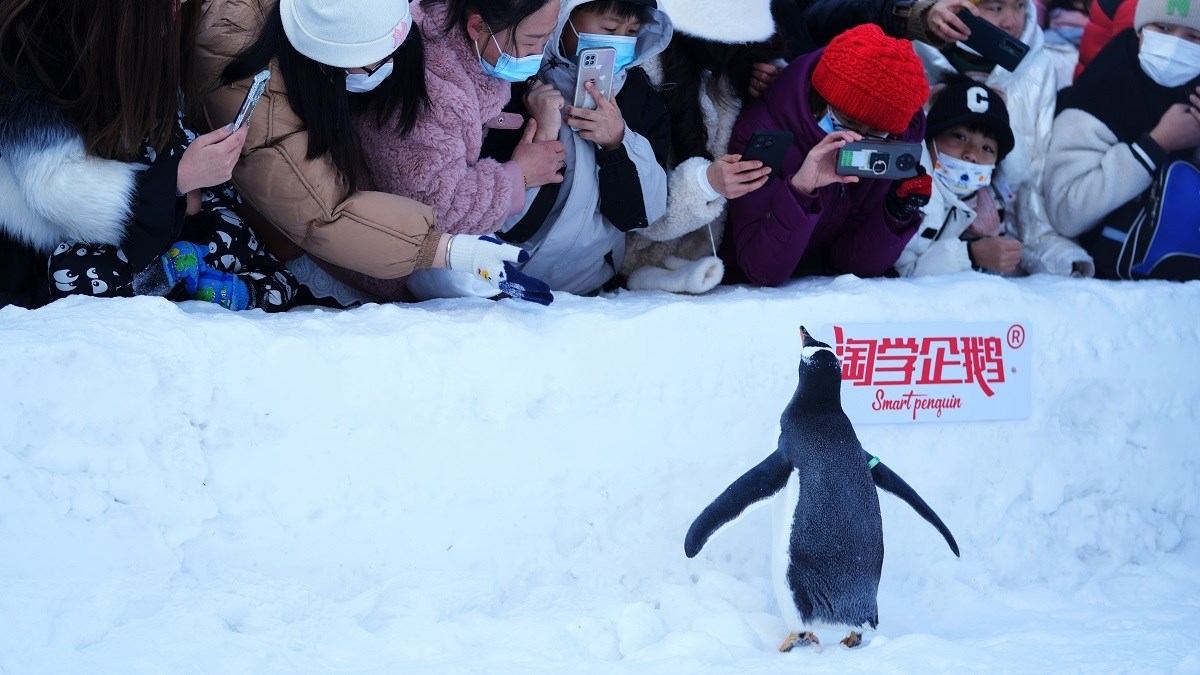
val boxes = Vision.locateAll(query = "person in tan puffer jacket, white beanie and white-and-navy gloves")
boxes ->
[196,0,552,300]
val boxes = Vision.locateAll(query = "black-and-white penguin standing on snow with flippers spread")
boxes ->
[684,325,959,652]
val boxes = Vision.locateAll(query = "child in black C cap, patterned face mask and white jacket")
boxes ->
[895,79,1093,276]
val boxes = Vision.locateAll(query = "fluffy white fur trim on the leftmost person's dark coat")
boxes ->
[0,83,136,253]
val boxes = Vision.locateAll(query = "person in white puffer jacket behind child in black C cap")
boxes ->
[913,0,1087,275]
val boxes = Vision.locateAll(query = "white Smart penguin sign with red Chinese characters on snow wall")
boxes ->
[814,322,1033,424]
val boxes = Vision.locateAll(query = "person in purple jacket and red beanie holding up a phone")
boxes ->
[721,24,932,286]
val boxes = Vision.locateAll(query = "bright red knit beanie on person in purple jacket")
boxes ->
[812,24,929,133]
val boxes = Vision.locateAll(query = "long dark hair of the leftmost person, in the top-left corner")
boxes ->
[0,0,200,162]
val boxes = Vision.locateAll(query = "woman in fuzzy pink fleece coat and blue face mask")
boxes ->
[356,0,563,234]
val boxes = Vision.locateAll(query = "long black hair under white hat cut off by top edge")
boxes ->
[660,32,784,163]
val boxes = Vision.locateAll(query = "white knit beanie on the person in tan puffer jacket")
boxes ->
[280,0,413,68]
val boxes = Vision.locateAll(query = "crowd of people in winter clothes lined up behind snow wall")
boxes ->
[0,0,1200,311]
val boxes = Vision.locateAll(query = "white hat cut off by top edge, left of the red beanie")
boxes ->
[659,0,772,44]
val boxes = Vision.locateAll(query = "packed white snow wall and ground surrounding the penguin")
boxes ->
[0,275,1200,673]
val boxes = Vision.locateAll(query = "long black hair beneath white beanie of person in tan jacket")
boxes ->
[221,4,430,190]
